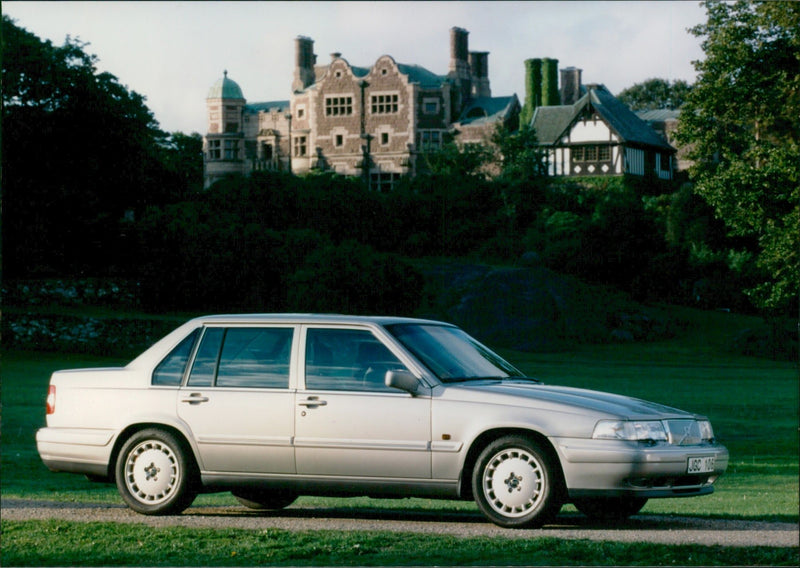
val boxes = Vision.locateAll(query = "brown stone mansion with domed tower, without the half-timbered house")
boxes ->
[204,28,520,191]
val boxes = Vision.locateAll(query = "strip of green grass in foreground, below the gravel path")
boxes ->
[2,521,798,566]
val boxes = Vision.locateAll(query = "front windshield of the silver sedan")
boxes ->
[387,324,524,382]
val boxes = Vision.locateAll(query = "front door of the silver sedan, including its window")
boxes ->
[295,326,431,479]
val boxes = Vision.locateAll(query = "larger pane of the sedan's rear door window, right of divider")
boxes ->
[217,328,294,389]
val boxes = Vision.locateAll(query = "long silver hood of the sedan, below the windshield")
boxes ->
[447,380,695,419]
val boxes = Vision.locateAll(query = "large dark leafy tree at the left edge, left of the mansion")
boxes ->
[2,16,169,276]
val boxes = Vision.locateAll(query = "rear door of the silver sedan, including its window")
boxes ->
[177,326,296,473]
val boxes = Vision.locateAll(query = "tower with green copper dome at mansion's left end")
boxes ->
[203,71,246,187]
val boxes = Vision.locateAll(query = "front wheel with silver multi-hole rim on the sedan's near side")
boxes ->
[472,436,563,528]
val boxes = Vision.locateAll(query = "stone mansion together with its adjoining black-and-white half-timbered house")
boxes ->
[203,28,677,191]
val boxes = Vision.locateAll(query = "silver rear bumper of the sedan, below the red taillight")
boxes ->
[36,428,116,476]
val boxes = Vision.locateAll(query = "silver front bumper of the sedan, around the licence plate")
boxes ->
[556,438,729,498]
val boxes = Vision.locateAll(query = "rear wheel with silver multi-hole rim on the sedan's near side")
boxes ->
[116,429,198,515]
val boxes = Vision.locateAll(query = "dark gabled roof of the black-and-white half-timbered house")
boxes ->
[531,85,675,151]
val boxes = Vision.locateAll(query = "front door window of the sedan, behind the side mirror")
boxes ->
[306,329,404,393]
